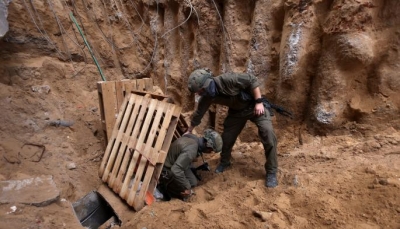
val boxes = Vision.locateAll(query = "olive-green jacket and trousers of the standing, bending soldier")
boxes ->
[191,73,278,173]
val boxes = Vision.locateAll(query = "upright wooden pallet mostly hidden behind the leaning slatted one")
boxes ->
[97,78,153,143]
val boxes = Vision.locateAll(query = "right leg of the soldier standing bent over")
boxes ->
[251,110,278,174]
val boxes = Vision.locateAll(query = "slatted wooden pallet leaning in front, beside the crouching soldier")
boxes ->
[99,94,182,210]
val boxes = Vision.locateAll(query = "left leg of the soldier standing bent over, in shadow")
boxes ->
[216,115,247,172]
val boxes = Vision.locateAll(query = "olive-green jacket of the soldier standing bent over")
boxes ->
[191,73,260,126]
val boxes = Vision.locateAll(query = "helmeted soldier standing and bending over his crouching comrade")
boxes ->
[187,69,278,188]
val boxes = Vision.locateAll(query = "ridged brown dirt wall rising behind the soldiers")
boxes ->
[3,0,400,136]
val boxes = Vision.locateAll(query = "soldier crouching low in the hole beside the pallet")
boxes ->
[158,129,222,201]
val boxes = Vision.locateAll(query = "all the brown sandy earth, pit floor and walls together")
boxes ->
[0,0,400,229]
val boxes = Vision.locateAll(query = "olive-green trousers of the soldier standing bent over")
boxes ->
[221,109,278,173]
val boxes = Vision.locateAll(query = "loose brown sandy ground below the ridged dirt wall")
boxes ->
[0,64,400,228]
